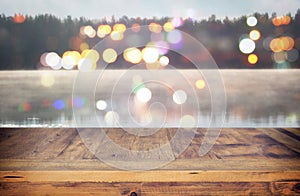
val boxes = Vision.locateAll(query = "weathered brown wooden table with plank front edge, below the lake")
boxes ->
[0,128,300,195]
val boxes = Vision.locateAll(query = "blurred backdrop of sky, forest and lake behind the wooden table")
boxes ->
[0,0,300,127]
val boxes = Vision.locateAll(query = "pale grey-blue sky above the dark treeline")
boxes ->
[0,0,300,19]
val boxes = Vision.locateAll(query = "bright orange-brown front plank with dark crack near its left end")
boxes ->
[0,170,300,182]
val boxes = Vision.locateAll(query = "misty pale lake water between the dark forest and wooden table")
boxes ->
[0,70,300,127]
